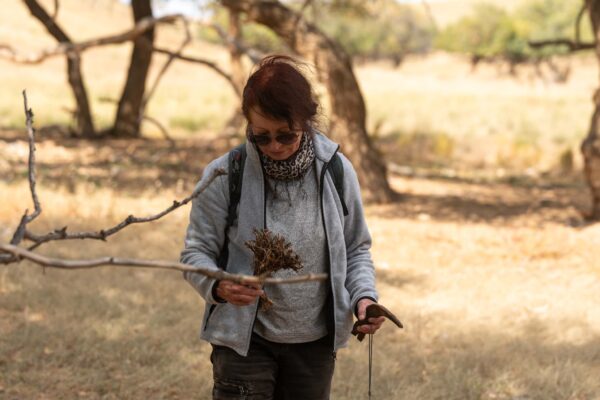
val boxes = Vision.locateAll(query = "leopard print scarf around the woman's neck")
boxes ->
[260,132,315,182]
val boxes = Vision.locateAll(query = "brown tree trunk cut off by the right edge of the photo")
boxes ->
[581,0,600,221]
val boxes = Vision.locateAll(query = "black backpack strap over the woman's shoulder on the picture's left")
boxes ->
[217,143,246,270]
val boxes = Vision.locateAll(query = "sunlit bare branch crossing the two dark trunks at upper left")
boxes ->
[0,15,183,64]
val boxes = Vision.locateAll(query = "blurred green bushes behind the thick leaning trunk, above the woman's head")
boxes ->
[198,0,433,62]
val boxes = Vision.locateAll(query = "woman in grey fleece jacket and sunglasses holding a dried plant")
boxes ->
[181,56,384,400]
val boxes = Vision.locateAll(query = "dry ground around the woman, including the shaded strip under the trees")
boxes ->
[0,136,600,400]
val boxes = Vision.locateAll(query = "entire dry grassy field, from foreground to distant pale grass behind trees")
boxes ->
[0,0,600,400]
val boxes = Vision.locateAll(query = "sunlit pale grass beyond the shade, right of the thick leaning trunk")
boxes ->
[357,53,598,171]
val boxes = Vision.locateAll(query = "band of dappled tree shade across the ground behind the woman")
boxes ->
[0,129,589,227]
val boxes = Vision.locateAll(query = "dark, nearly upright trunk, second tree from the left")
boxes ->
[112,0,154,137]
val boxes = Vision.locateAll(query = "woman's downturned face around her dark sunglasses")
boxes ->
[249,110,302,161]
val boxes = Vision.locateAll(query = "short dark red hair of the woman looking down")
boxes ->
[242,55,319,132]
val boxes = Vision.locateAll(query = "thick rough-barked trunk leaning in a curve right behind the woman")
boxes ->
[221,0,394,203]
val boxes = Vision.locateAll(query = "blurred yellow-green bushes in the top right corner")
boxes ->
[435,0,591,62]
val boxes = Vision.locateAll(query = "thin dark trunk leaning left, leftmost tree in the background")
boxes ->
[24,0,96,137]
